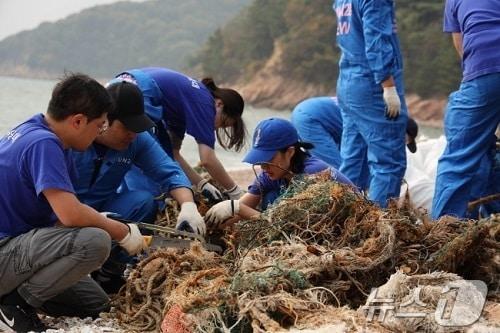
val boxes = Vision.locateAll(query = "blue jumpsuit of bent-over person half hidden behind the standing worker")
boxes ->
[291,96,370,189]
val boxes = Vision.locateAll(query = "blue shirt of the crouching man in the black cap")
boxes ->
[73,132,191,209]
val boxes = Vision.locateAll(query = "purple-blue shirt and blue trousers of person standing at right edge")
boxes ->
[432,0,500,219]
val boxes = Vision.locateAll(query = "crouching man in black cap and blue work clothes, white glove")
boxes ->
[73,81,205,294]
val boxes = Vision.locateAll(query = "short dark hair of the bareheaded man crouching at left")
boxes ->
[47,73,114,121]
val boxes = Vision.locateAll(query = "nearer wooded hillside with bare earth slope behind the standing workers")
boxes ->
[191,0,460,107]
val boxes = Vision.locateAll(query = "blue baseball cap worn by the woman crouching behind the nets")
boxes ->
[243,118,299,164]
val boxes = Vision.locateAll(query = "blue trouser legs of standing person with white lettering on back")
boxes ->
[337,73,408,207]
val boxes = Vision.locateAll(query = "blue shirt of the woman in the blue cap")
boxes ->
[248,156,355,210]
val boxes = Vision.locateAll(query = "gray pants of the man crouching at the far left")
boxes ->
[0,227,111,317]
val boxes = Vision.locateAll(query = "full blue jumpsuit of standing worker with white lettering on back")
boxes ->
[334,0,408,207]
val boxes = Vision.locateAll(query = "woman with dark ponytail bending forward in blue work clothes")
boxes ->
[112,67,246,202]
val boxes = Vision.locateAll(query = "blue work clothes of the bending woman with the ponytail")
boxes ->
[115,67,216,195]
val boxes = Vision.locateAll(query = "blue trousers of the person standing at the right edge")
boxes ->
[432,73,500,219]
